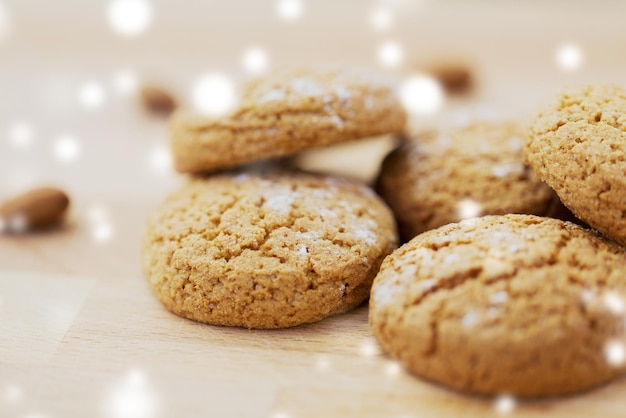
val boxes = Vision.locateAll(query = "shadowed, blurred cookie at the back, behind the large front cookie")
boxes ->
[377,122,556,241]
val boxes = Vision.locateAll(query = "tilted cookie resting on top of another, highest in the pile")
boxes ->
[171,69,406,172]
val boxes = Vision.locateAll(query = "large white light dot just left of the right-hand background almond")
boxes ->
[400,75,444,115]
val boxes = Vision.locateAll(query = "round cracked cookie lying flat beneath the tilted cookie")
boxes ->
[143,172,397,328]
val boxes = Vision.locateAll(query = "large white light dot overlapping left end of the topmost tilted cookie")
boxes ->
[192,73,237,116]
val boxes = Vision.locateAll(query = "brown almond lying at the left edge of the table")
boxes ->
[0,187,70,233]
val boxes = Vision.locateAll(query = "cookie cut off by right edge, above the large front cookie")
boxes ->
[525,85,626,245]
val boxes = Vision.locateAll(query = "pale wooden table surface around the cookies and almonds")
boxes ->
[0,0,626,418]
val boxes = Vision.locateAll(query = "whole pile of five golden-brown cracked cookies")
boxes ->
[143,66,626,396]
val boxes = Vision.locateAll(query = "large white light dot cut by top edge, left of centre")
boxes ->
[107,0,152,36]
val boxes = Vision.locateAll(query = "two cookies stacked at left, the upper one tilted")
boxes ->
[143,69,406,328]
